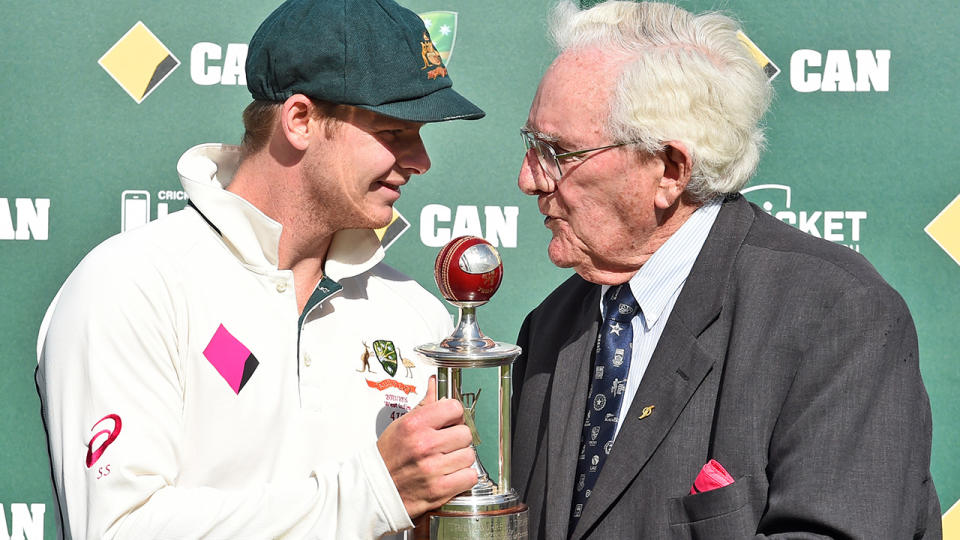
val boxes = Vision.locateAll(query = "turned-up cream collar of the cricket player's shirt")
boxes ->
[177,144,383,280]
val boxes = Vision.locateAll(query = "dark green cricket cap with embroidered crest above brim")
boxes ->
[246,0,485,122]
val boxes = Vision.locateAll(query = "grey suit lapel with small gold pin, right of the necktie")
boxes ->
[565,196,753,538]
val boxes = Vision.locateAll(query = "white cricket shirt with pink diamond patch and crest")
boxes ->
[37,144,452,539]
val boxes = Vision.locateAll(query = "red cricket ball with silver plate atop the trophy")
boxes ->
[433,236,503,302]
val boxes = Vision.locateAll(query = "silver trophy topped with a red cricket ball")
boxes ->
[416,236,527,540]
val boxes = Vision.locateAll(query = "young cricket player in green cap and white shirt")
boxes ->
[37,0,483,539]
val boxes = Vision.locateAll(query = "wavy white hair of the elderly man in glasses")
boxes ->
[550,1,772,200]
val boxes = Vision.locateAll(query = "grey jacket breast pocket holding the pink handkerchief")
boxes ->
[669,475,757,539]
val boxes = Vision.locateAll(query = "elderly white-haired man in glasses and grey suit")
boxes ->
[513,2,940,539]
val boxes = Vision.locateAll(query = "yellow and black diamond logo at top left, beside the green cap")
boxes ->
[97,21,180,103]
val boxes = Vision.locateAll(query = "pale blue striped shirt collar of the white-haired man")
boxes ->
[601,198,722,330]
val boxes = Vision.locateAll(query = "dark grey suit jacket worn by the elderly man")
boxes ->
[512,196,941,539]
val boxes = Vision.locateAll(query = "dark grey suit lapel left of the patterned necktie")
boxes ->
[544,286,600,538]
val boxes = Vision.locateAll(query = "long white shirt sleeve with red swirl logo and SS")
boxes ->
[37,242,411,539]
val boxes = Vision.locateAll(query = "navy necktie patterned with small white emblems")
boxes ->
[568,283,640,534]
